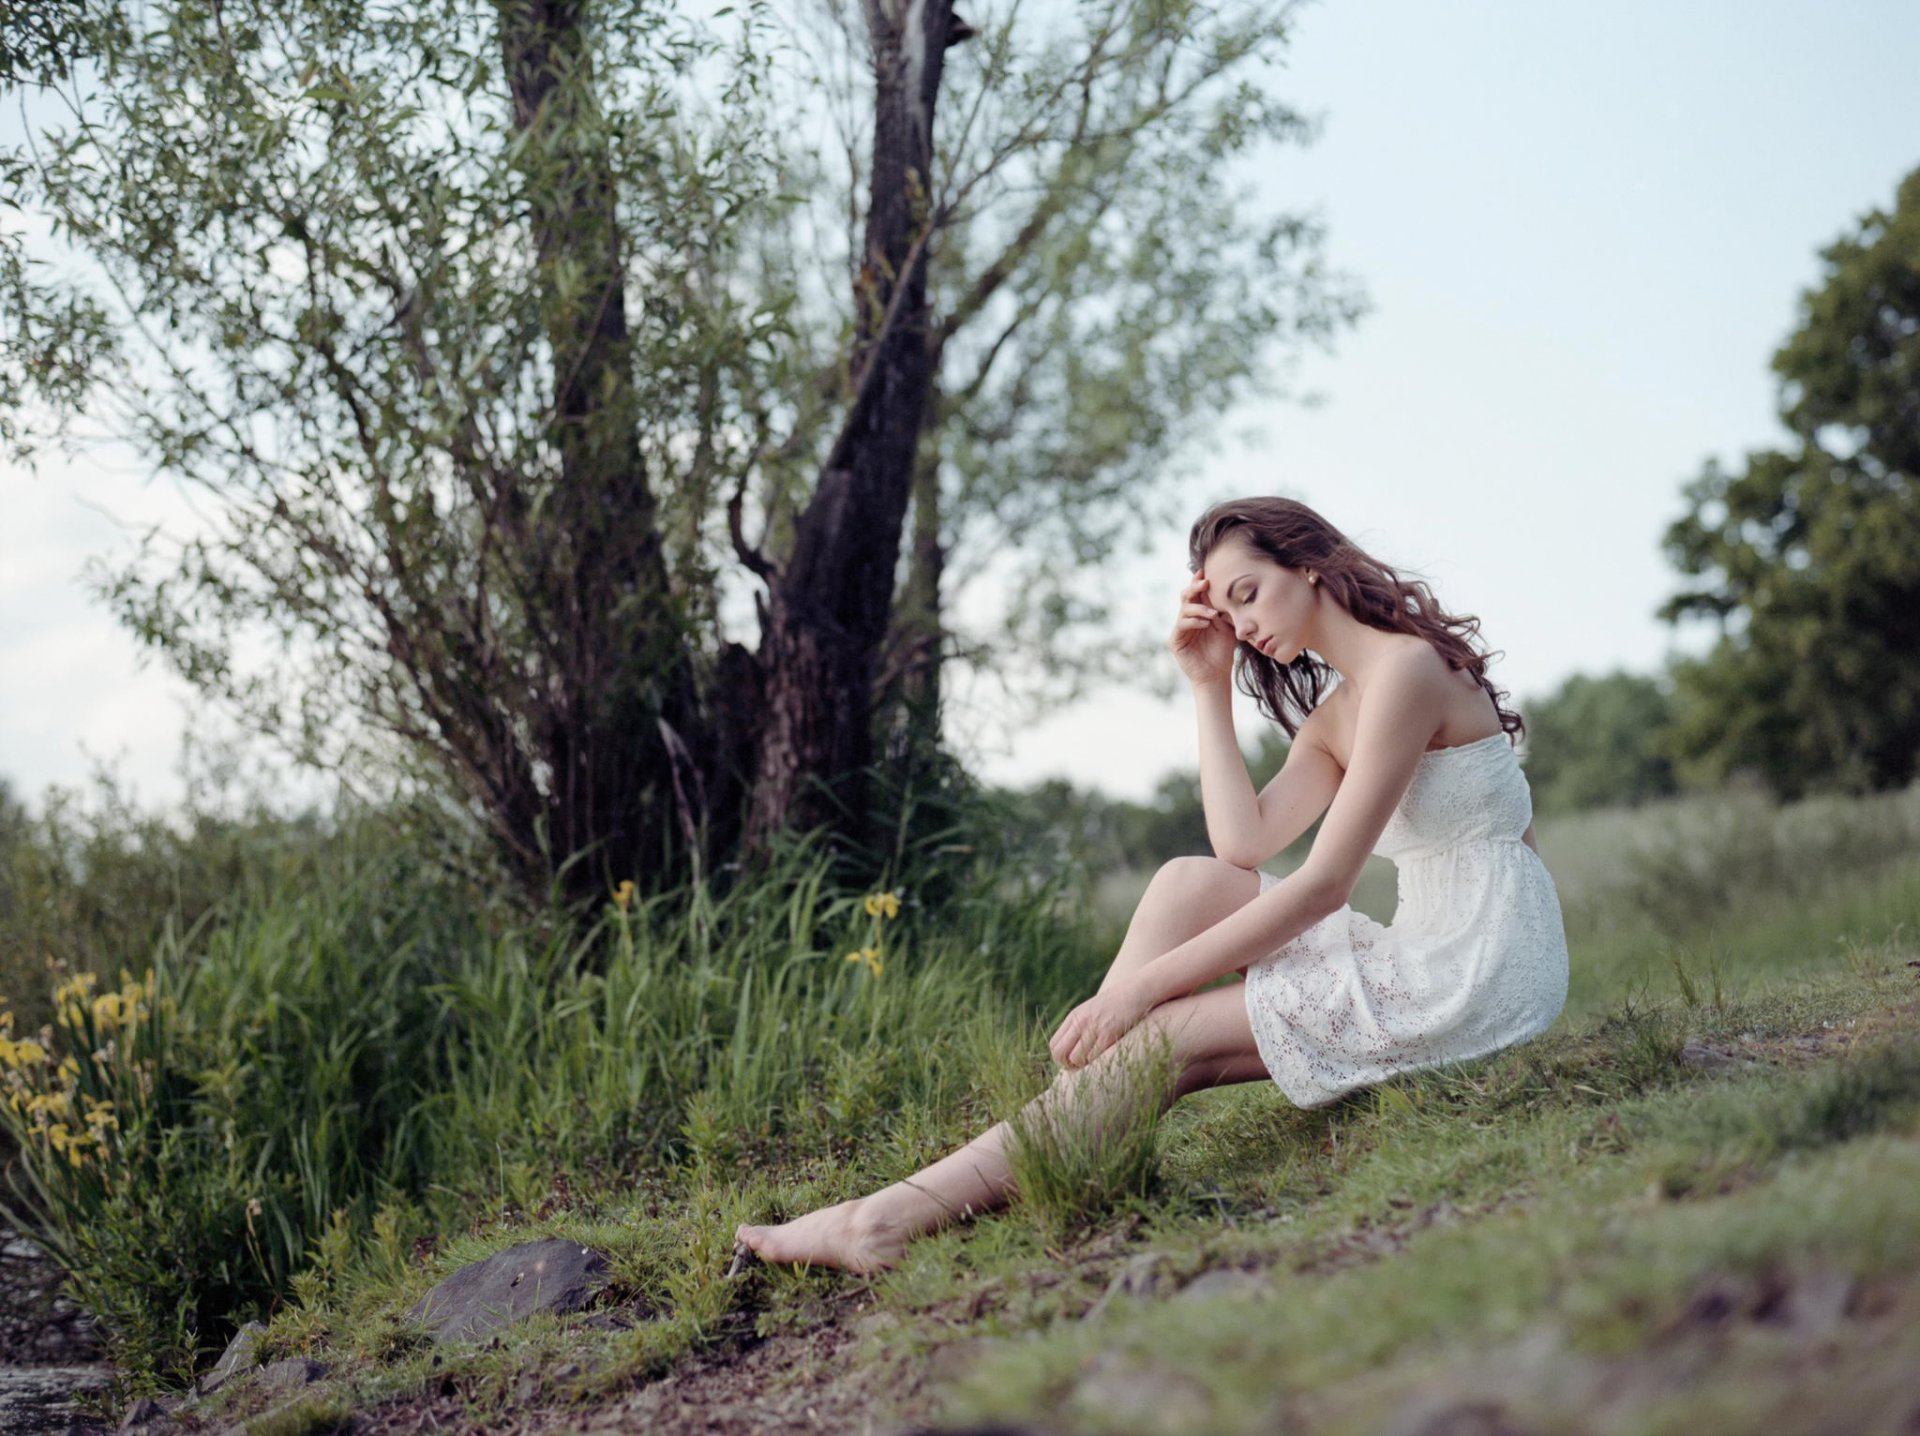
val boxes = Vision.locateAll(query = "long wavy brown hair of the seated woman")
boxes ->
[1187,497,1526,741]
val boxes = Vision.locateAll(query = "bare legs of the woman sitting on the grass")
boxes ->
[735,858,1267,1271]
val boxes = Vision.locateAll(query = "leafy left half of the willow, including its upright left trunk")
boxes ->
[0,0,787,893]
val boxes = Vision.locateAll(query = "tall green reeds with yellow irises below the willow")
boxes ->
[0,767,1096,1386]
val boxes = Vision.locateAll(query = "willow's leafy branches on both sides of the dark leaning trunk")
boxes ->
[0,0,1357,897]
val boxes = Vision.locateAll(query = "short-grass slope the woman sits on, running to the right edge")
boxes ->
[172,841,1920,1432]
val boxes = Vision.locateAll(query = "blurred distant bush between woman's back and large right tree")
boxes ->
[1523,670,1676,814]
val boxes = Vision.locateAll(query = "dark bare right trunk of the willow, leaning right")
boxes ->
[747,0,952,850]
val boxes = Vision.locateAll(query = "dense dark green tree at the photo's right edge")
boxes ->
[1661,171,1920,797]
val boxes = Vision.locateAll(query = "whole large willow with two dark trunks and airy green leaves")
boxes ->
[0,0,1374,891]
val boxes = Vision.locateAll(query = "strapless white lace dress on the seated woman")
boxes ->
[1246,733,1567,1108]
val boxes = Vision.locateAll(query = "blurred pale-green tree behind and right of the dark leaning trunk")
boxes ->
[748,0,1365,775]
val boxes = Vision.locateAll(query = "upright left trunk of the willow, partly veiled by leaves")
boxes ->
[499,0,708,893]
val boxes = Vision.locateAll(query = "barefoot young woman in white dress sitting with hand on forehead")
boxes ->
[735,497,1567,1271]
